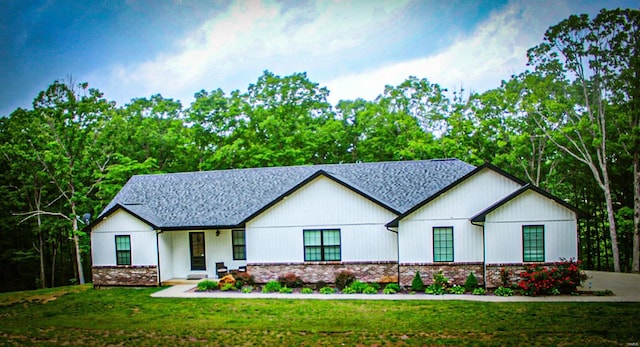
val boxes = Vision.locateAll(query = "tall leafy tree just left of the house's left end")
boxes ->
[33,81,113,284]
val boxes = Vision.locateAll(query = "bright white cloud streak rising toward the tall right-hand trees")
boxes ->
[323,0,571,103]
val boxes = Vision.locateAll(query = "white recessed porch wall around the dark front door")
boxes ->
[165,229,247,280]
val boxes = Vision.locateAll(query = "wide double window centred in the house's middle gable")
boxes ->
[303,229,340,261]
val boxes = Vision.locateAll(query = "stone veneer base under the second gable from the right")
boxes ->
[400,262,484,286]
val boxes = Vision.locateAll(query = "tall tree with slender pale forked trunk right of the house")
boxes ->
[528,10,640,272]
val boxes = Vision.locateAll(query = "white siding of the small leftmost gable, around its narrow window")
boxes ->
[91,210,158,266]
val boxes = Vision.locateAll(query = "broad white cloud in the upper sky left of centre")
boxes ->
[87,0,405,106]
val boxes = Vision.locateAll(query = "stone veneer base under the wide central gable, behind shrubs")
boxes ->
[247,261,398,283]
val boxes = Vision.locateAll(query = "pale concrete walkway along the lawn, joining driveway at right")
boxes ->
[151,271,640,302]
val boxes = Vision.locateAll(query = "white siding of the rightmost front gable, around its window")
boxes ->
[485,190,578,264]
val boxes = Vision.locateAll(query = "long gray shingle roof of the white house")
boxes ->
[101,159,475,229]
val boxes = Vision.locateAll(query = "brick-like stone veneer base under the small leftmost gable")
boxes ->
[91,265,158,287]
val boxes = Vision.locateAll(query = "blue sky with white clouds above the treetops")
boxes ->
[0,0,638,115]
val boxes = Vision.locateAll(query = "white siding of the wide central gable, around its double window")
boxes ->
[246,176,397,263]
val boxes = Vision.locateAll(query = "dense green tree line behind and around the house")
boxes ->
[0,10,640,291]
